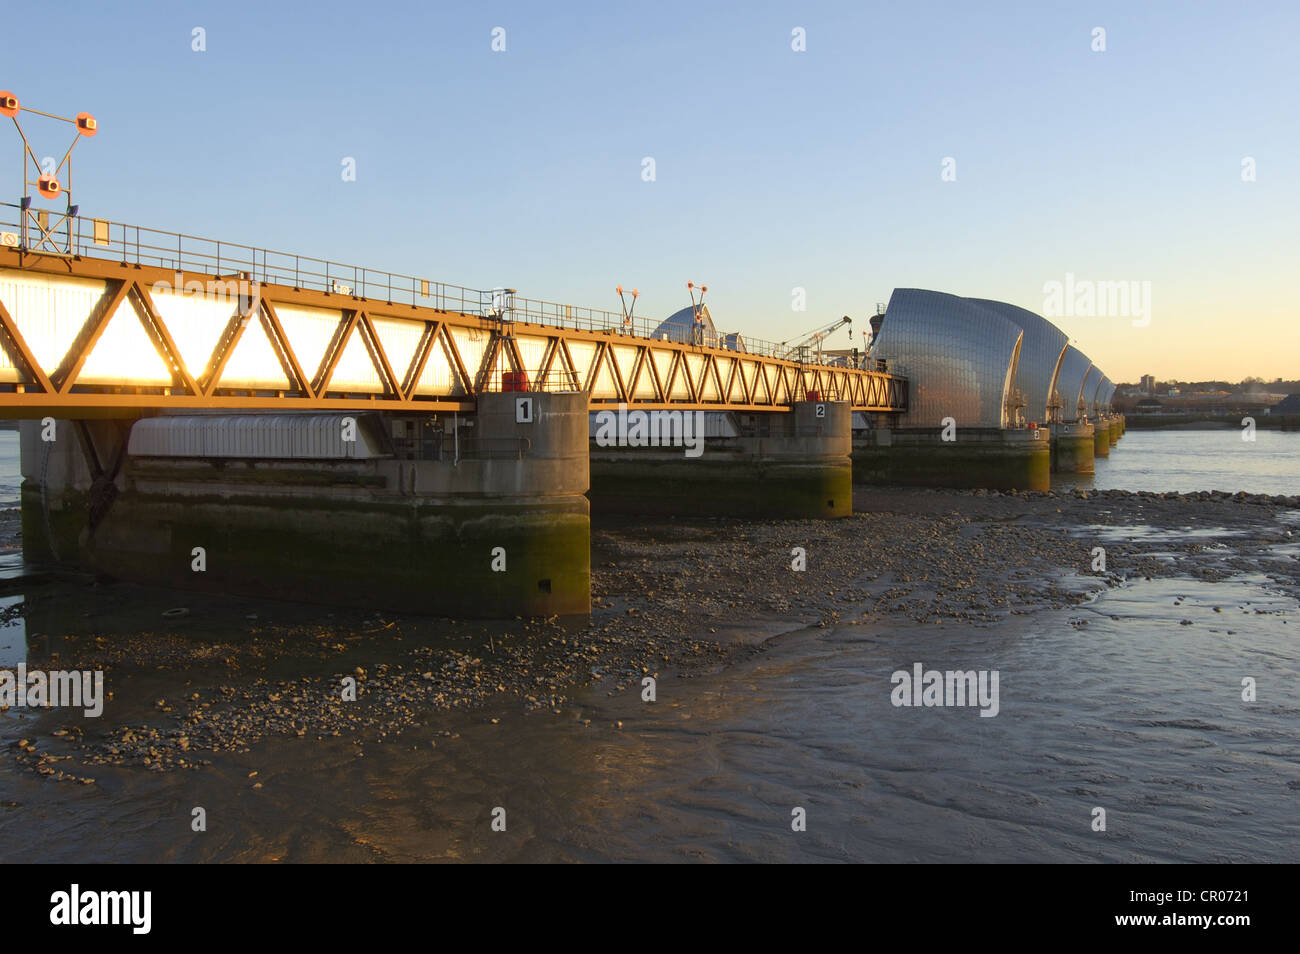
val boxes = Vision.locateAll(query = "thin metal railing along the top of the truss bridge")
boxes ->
[0,203,794,360]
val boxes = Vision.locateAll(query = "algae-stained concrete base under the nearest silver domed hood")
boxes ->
[853,428,1052,490]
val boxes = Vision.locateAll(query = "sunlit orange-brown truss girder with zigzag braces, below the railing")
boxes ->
[0,256,907,416]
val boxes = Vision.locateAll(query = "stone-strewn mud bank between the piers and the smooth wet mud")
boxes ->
[0,490,1300,857]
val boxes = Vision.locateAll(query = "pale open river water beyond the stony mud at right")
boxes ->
[1052,428,1300,496]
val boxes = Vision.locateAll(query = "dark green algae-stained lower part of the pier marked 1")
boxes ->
[23,486,590,617]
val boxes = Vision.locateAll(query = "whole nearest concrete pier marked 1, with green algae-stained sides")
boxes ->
[22,394,590,617]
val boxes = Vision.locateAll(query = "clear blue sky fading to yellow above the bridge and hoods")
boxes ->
[0,0,1300,380]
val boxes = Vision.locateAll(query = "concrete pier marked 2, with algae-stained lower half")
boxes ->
[589,402,853,520]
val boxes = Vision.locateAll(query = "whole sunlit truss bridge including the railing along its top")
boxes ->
[0,205,907,417]
